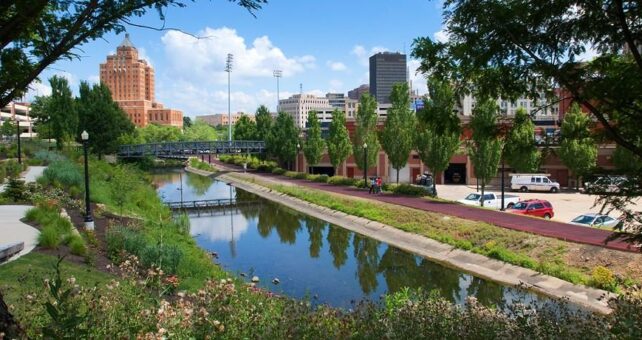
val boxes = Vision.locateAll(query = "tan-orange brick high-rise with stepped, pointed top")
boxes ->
[100,34,183,127]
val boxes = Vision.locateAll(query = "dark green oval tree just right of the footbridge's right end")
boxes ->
[268,112,299,169]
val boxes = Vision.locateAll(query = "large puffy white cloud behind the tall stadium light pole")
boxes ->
[161,27,316,84]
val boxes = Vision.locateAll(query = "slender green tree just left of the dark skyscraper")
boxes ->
[352,93,381,177]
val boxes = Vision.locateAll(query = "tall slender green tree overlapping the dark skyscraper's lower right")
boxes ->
[380,82,415,183]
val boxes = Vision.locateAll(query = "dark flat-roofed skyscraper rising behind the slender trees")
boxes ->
[370,52,408,104]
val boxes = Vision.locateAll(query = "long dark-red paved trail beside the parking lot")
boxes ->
[212,161,639,252]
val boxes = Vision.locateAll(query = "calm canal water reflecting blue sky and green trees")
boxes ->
[154,170,560,309]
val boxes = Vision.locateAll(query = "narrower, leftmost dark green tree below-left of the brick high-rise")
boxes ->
[32,76,78,149]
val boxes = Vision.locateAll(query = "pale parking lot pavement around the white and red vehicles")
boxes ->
[437,185,642,222]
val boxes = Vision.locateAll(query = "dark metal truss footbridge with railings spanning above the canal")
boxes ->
[118,140,265,158]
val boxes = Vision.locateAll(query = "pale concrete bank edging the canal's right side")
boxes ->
[187,168,613,313]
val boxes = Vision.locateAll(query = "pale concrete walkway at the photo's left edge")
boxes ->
[0,166,46,263]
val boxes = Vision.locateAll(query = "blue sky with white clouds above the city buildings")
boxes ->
[27,0,446,117]
